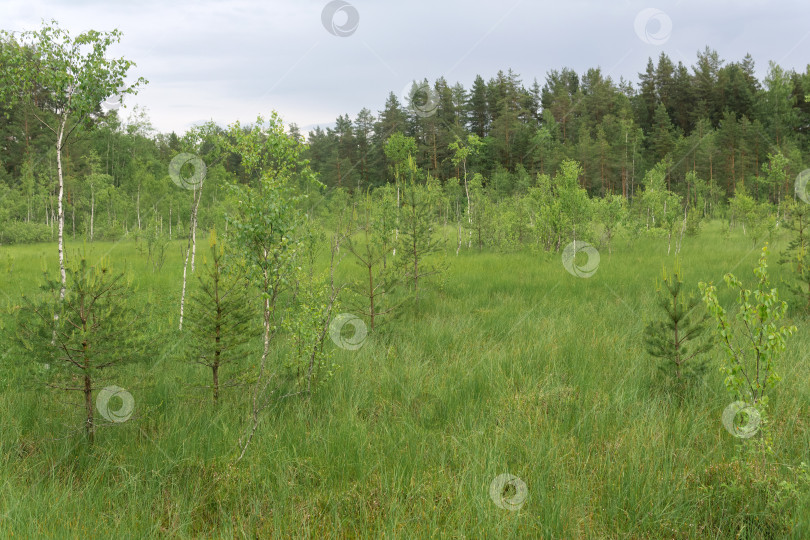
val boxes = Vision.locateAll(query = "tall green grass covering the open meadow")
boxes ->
[0,223,810,539]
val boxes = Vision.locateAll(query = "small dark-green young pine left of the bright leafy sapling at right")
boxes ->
[644,259,712,383]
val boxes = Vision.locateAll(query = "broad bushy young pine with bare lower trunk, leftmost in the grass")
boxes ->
[17,255,145,444]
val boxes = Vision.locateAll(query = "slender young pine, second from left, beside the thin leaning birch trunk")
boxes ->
[187,230,256,403]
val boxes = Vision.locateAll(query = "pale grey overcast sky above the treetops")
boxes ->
[0,0,810,133]
